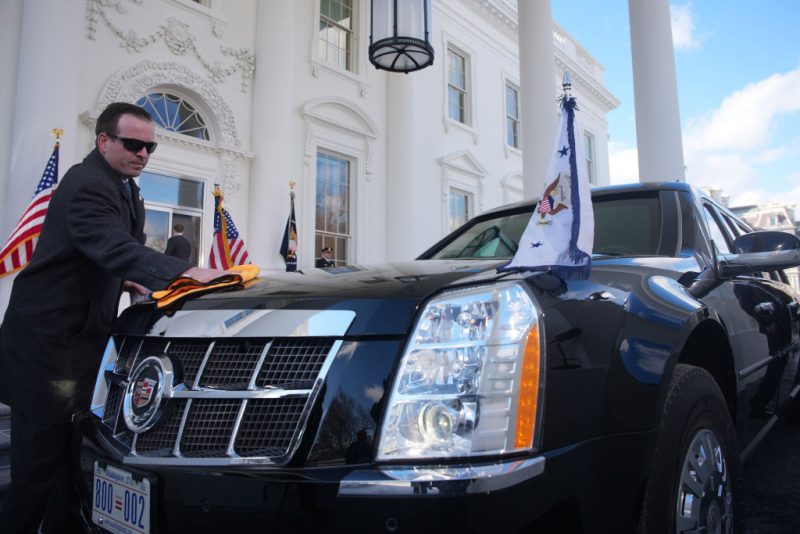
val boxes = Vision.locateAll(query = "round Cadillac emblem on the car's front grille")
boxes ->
[122,355,174,434]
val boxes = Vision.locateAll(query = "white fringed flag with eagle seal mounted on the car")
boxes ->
[498,95,594,280]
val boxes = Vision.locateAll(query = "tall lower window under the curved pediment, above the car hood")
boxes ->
[314,152,351,266]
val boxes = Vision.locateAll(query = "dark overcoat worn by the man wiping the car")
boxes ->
[0,149,191,423]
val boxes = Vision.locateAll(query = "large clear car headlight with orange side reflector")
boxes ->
[378,283,543,460]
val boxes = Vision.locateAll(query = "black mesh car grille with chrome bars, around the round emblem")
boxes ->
[102,337,342,465]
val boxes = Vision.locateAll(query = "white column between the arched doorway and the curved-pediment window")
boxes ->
[245,0,296,268]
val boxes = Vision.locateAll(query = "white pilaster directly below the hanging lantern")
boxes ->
[386,72,422,261]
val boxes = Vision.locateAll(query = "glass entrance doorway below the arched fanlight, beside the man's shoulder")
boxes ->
[138,172,204,265]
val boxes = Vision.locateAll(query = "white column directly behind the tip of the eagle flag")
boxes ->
[518,0,558,198]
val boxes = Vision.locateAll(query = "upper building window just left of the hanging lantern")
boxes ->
[319,0,353,70]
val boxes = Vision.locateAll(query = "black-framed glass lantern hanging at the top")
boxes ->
[369,0,433,72]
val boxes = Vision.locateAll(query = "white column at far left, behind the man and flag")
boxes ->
[0,0,86,316]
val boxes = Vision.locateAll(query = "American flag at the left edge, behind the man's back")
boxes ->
[0,141,58,277]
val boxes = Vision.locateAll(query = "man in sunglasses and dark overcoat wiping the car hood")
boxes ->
[0,102,224,534]
